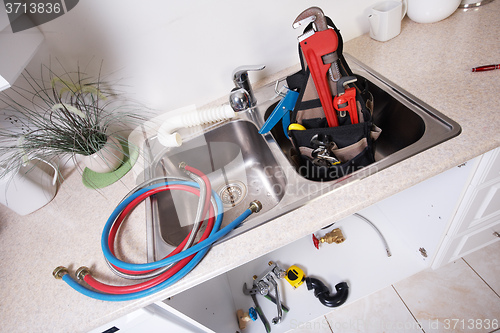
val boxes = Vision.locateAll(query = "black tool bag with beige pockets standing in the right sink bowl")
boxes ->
[286,17,381,181]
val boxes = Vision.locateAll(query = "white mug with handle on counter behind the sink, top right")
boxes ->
[368,1,406,42]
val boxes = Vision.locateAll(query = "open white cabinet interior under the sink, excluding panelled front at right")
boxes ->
[158,159,478,333]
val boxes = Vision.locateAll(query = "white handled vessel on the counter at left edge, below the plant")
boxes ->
[0,158,58,215]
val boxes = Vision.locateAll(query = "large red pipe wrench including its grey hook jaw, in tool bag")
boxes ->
[292,7,340,127]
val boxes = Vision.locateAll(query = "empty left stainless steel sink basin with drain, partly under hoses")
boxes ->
[143,119,286,254]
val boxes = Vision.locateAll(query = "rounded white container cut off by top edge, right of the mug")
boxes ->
[408,0,460,23]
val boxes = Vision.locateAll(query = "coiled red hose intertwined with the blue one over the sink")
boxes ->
[84,178,215,294]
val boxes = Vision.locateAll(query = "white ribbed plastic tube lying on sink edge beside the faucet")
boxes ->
[158,105,235,147]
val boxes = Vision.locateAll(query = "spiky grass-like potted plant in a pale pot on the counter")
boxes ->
[0,62,144,182]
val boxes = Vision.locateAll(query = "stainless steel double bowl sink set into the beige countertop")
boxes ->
[145,54,461,260]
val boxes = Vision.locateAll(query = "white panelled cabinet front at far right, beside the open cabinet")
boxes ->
[432,148,500,268]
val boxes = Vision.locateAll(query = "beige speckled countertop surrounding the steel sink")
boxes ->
[0,1,500,332]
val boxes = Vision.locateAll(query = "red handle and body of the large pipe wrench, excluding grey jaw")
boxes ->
[300,29,339,127]
